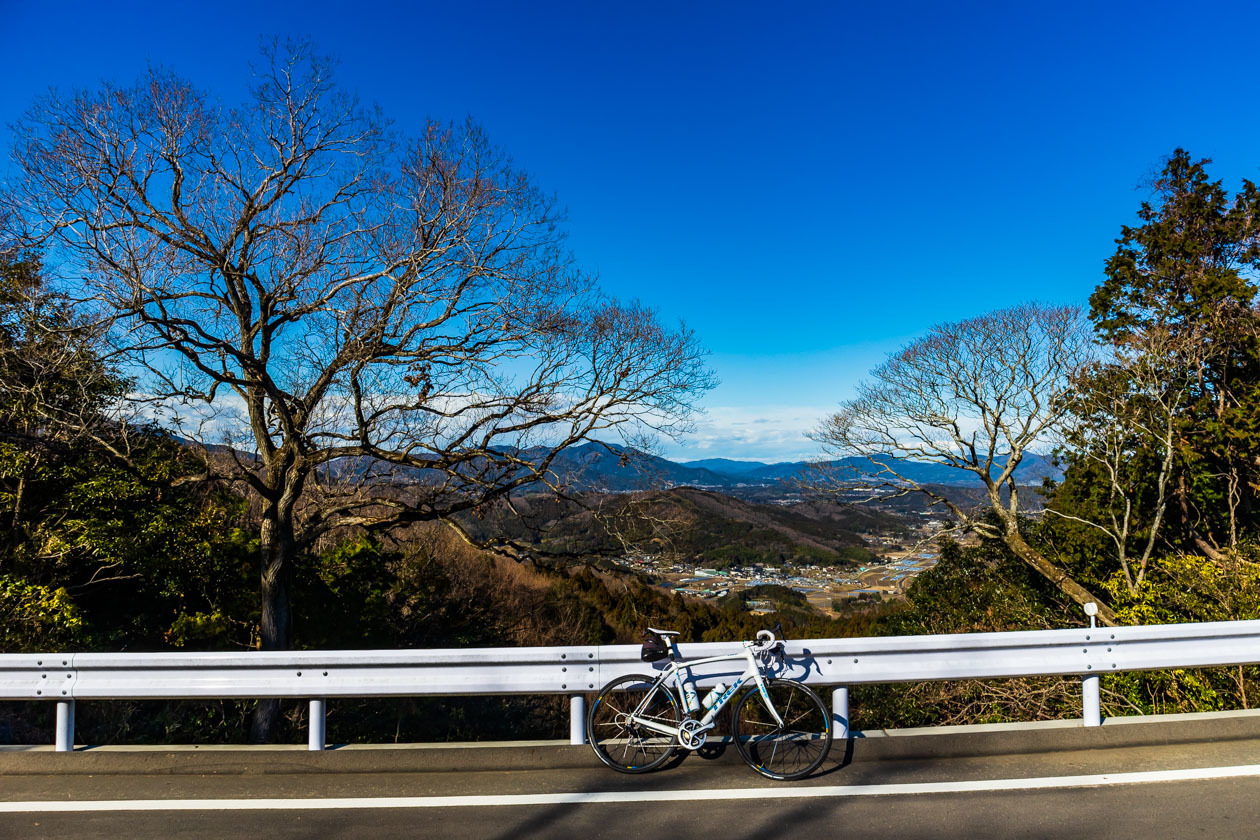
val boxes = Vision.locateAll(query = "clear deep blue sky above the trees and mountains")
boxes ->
[0,0,1260,461]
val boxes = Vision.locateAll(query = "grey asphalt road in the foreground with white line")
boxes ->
[0,729,1260,840]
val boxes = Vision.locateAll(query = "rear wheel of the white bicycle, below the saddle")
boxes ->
[586,674,682,773]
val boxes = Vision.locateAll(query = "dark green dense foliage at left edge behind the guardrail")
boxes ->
[0,258,252,651]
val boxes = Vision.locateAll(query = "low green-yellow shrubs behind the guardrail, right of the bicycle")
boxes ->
[852,542,1260,728]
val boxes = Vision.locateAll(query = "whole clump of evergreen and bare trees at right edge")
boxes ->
[1040,149,1260,621]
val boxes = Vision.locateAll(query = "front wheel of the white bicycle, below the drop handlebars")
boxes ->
[731,679,832,782]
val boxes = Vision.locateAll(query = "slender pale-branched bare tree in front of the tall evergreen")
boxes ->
[1047,325,1210,592]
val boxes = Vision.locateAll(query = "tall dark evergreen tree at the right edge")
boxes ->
[1090,149,1260,559]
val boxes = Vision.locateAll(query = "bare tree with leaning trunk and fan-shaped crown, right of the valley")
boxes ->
[814,304,1115,623]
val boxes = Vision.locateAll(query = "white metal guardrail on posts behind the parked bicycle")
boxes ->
[0,621,1260,751]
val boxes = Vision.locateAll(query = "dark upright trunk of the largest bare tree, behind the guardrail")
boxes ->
[249,509,297,744]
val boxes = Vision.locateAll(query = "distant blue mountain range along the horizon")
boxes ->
[527,443,1061,492]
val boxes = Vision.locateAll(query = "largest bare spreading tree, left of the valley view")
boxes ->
[4,44,711,730]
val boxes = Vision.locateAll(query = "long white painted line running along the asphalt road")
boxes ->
[0,764,1260,814]
